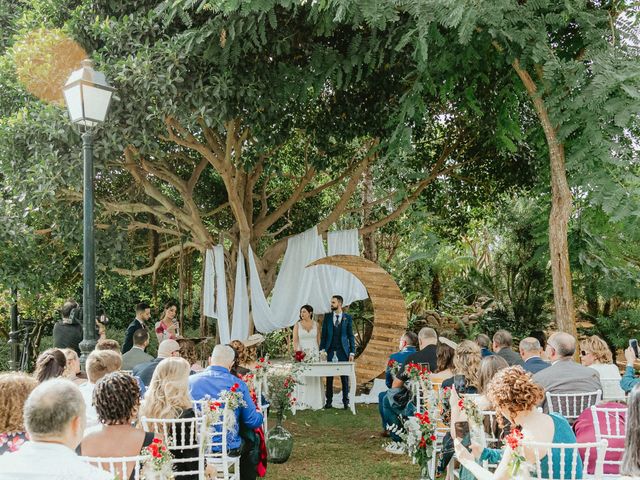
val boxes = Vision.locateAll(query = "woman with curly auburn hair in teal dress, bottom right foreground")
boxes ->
[455,366,582,480]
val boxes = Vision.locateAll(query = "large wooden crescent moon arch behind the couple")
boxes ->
[307,255,407,384]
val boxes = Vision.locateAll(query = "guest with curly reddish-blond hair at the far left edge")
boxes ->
[0,372,38,455]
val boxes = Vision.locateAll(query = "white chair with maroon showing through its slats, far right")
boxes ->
[590,405,627,478]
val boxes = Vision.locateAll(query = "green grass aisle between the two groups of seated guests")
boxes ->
[266,405,420,480]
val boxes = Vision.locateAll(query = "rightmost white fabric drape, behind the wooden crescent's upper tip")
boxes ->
[327,228,369,305]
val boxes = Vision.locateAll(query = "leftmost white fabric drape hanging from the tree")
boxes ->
[203,245,231,343]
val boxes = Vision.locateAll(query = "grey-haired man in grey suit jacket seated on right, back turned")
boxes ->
[533,332,602,407]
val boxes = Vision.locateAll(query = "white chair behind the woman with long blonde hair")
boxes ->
[140,417,203,478]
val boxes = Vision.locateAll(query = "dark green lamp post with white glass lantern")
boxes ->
[63,60,115,369]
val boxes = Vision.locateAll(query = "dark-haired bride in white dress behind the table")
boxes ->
[293,305,324,410]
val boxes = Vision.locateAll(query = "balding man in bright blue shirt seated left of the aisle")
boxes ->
[189,345,262,480]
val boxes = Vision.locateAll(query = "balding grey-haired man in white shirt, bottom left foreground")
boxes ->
[0,378,113,480]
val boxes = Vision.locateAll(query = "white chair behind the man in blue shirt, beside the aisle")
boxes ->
[199,400,240,480]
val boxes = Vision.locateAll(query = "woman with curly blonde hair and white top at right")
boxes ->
[580,335,625,400]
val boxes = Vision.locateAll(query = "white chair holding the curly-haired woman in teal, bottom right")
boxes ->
[522,440,607,480]
